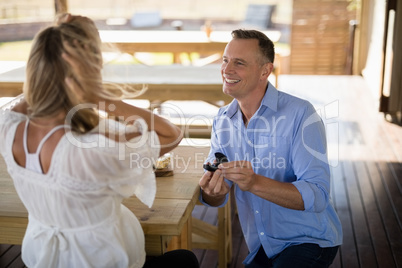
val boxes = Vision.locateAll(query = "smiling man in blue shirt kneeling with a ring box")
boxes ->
[199,30,342,267]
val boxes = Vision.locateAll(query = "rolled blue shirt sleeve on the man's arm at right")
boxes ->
[291,104,330,212]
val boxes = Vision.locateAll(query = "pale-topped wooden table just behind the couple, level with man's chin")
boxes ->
[0,64,232,103]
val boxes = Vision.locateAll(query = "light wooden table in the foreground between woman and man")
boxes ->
[0,146,209,255]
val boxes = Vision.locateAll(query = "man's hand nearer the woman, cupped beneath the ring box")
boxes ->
[199,169,230,206]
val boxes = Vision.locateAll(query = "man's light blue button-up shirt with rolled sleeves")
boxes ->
[201,84,342,263]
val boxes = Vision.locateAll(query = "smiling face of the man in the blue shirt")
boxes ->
[221,39,267,99]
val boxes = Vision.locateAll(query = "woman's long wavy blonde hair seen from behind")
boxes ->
[23,14,143,133]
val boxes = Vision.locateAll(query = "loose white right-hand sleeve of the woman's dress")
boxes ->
[65,119,160,207]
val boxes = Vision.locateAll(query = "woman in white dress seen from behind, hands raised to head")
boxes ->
[0,14,198,267]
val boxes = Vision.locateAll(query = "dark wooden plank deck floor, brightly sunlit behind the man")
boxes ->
[0,75,402,268]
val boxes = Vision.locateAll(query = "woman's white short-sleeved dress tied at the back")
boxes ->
[0,111,160,268]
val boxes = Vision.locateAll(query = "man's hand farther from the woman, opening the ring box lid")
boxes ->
[219,161,257,191]
